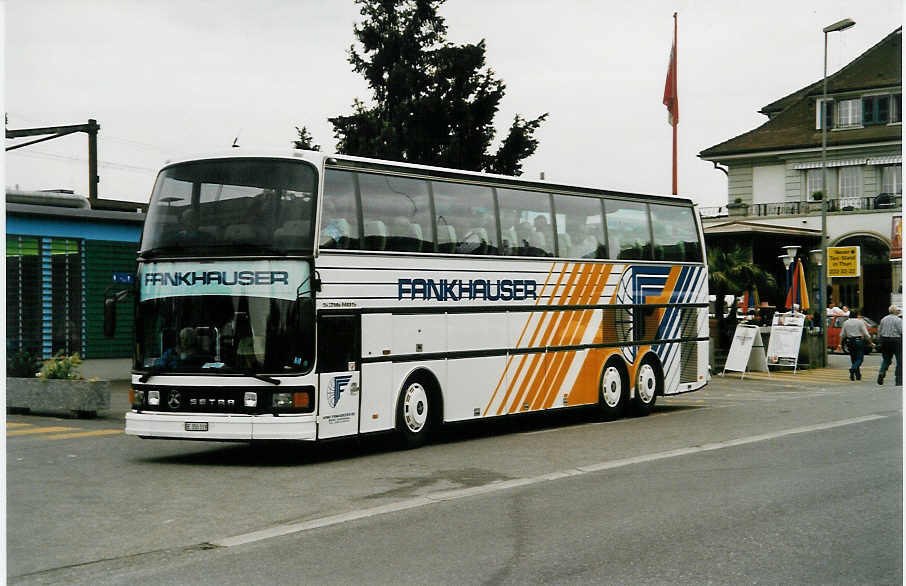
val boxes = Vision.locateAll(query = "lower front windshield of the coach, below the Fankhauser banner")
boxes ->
[135,295,314,374]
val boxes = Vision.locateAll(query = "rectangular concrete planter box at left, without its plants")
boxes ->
[6,377,110,417]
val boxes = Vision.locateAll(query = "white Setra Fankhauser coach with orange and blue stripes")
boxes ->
[126,149,709,446]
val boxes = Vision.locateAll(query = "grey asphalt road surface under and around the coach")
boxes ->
[7,357,903,584]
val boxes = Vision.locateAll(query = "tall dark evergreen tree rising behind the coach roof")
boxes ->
[296,0,547,175]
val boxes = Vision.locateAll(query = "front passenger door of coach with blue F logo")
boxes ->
[317,315,362,439]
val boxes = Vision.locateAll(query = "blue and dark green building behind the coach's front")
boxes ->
[6,191,145,359]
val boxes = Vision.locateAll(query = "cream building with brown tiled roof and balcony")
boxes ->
[699,27,903,318]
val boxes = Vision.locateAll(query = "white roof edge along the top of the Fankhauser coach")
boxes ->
[164,147,694,205]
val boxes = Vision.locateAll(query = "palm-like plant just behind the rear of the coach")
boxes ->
[708,245,777,347]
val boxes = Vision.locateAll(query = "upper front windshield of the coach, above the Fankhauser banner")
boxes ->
[140,158,316,258]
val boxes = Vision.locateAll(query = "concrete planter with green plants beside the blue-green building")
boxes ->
[6,351,110,417]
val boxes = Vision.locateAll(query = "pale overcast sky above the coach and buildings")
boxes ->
[5,0,903,206]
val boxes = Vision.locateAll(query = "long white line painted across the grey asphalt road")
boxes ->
[209,415,888,547]
